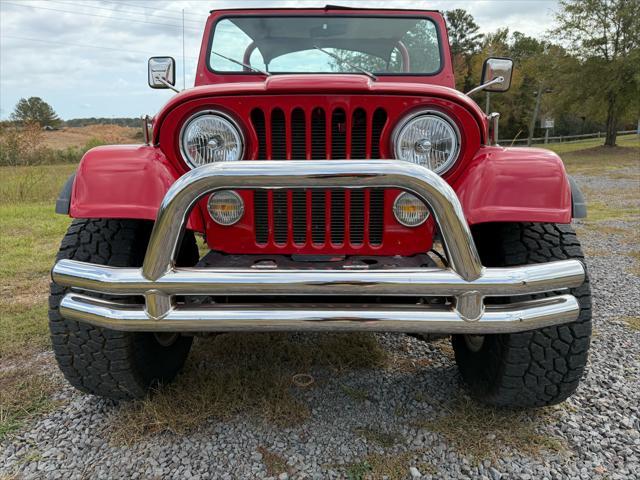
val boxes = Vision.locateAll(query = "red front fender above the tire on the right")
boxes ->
[453,147,571,224]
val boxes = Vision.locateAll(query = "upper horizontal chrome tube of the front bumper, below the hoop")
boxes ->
[52,260,585,297]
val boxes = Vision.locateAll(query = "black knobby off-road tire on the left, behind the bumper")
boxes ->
[49,219,198,400]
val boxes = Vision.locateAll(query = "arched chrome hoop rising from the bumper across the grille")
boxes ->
[142,160,482,281]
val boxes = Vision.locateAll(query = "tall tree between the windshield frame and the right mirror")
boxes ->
[445,8,483,90]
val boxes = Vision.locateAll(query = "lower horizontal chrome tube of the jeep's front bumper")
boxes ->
[60,293,580,335]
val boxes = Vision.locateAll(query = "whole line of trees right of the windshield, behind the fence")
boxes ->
[446,0,640,146]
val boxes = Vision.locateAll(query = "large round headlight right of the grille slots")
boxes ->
[393,112,460,174]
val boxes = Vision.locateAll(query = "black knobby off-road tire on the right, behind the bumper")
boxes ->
[452,223,591,408]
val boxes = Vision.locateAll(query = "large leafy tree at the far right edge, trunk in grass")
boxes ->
[553,0,640,147]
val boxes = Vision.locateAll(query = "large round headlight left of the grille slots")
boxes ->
[180,112,244,167]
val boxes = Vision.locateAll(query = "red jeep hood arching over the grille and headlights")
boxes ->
[154,74,485,142]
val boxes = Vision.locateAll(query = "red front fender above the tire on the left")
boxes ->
[69,145,203,231]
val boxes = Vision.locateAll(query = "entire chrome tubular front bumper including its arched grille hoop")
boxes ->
[52,160,585,334]
